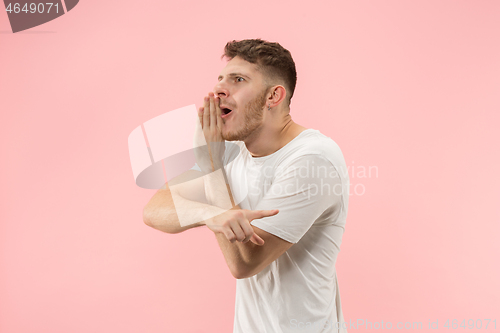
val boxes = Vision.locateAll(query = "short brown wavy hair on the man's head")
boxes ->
[221,39,297,106]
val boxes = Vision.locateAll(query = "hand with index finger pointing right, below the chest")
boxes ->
[206,209,279,245]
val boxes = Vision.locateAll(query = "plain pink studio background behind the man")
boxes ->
[0,0,500,333]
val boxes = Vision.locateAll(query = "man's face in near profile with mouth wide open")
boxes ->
[214,57,267,141]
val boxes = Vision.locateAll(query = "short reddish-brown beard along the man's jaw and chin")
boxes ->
[221,88,268,141]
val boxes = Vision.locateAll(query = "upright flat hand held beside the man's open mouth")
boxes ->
[195,93,225,173]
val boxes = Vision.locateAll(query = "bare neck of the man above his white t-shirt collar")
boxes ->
[244,114,307,157]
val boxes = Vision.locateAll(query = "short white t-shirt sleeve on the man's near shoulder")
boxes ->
[251,154,342,243]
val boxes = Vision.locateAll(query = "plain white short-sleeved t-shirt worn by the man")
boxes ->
[194,129,349,333]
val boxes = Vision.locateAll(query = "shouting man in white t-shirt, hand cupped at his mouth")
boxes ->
[144,39,349,333]
